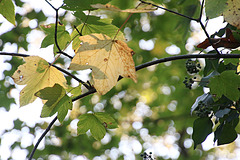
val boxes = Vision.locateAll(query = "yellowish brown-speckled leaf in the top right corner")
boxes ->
[223,0,240,29]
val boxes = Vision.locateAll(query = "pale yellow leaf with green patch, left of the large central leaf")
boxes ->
[12,56,66,106]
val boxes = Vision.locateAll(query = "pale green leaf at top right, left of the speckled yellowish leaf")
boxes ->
[205,0,227,19]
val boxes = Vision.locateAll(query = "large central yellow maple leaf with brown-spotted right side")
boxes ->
[69,33,137,95]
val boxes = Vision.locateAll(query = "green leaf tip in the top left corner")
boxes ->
[0,0,16,26]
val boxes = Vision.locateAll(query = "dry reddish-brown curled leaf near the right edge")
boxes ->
[197,28,240,49]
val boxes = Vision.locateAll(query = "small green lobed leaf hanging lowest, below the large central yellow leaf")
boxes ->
[77,112,117,141]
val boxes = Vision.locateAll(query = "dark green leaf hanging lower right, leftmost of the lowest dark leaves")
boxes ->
[192,117,213,149]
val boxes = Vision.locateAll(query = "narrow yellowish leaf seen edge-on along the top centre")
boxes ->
[91,3,157,13]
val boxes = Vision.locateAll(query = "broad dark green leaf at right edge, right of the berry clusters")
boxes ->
[209,70,240,101]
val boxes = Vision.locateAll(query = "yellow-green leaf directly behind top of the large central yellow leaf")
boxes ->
[71,19,125,50]
